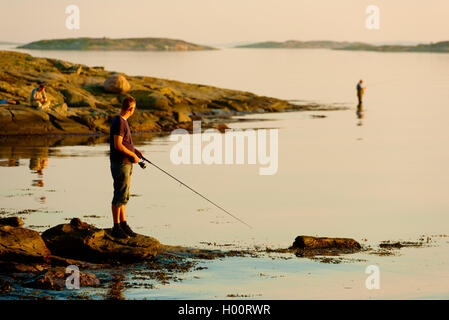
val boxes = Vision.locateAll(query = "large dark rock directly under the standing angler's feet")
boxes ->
[42,219,162,263]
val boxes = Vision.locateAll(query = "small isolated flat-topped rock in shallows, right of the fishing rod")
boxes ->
[292,236,362,250]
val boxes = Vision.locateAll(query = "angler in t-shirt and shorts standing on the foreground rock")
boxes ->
[109,97,143,239]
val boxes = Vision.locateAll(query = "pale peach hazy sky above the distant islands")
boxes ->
[0,0,449,44]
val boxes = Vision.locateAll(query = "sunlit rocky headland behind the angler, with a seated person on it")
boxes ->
[0,51,318,136]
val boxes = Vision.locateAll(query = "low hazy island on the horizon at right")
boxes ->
[235,40,449,53]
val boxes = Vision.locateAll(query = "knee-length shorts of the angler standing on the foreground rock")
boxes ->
[111,162,133,207]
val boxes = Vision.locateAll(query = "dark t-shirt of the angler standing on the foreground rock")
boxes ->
[109,116,134,163]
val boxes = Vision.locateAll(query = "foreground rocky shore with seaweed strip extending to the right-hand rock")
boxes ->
[0,212,431,299]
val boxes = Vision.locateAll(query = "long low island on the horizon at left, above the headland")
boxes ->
[18,38,215,51]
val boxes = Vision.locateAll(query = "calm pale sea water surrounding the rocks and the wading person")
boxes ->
[0,49,449,298]
